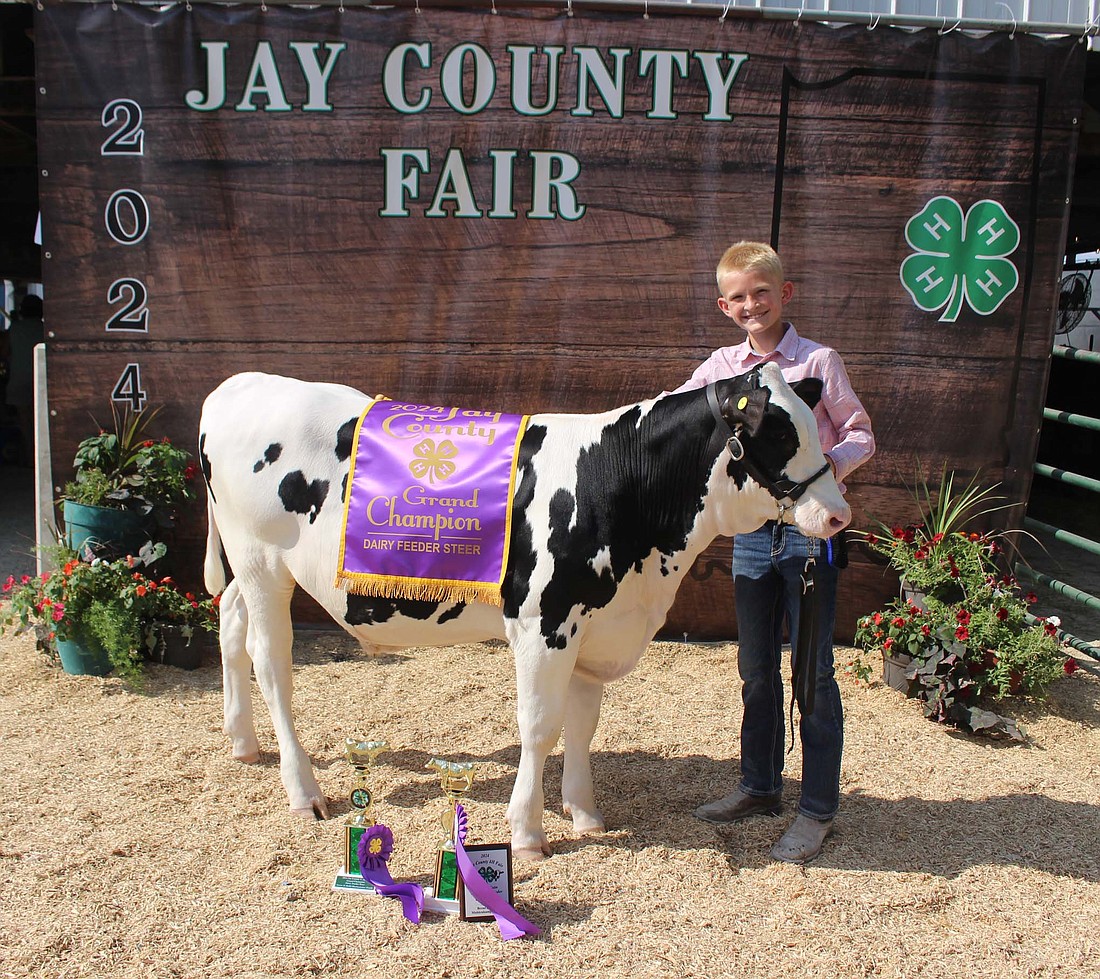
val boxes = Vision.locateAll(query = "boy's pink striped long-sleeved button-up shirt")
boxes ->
[677,323,875,491]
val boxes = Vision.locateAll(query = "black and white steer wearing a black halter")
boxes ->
[199,364,850,858]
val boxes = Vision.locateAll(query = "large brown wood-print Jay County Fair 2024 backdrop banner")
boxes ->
[35,2,1085,635]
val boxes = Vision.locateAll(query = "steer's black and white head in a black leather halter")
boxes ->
[707,363,851,537]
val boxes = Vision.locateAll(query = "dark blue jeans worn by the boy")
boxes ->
[734,521,844,820]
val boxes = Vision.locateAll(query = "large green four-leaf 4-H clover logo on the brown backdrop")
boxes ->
[901,197,1020,323]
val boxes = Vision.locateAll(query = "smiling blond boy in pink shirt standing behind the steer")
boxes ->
[678,241,875,864]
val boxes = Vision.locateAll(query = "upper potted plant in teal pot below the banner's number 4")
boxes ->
[62,403,198,558]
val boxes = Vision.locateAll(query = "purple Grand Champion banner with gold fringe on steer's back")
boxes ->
[336,400,528,605]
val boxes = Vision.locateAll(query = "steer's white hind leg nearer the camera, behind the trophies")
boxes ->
[241,574,329,820]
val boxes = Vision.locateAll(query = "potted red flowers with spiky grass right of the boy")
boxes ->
[851,473,1076,738]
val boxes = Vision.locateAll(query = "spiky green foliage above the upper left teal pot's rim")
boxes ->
[63,403,198,513]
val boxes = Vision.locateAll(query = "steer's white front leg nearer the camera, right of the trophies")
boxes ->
[508,630,576,860]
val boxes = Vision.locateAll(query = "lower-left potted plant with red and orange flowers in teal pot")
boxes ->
[0,545,218,679]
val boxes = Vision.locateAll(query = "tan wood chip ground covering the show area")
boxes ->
[0,633,1100,979]
